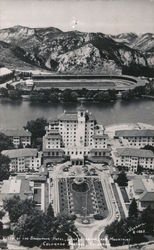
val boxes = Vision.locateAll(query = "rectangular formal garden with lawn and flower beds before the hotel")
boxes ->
[58,176,108,219]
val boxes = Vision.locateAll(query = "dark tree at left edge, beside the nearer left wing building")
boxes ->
[0,154,10,181]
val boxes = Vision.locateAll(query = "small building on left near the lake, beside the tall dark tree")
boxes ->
[0,129,31,148]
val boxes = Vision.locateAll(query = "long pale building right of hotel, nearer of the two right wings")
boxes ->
[113,148,154,171]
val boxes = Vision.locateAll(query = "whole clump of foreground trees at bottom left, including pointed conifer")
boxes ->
[4,196,78,248]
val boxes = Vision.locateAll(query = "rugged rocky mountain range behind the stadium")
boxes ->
[0,26,154,74]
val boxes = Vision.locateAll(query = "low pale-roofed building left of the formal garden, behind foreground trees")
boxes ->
[0,174,49,212]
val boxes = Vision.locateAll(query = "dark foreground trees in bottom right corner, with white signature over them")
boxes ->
[106,199,154,246]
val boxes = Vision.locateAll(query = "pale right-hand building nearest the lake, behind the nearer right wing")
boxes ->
[115,129,154,148]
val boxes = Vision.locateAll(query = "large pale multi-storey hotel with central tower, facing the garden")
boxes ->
[43,106,110,165]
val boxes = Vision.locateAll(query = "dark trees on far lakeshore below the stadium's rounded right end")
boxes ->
[122,83,154,101]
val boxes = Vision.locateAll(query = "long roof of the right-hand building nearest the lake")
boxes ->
[115,129,154,137]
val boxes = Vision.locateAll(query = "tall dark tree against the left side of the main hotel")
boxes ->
[24,118,48,147]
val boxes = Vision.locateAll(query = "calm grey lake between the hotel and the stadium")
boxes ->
[0,99,154,129]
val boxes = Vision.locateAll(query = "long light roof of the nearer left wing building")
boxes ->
[1,148,37,158]
